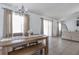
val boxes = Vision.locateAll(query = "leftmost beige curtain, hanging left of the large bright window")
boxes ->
[3,9,12,37]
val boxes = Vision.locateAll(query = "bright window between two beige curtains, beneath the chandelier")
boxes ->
[12,12,24,33]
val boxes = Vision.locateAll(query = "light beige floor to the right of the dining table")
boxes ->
[49,37,79,55]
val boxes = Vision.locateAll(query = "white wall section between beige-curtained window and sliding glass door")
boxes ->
[29,13,41,34]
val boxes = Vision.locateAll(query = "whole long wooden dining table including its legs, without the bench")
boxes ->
[0,35,48,55]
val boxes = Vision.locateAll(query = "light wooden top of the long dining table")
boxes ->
[0,35,48,47]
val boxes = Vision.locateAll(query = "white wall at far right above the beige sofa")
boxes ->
[64,13,79,32]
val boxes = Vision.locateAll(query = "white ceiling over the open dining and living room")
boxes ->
[3,3,79,18]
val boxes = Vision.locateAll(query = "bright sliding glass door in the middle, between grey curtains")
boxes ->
[43,20,53,36]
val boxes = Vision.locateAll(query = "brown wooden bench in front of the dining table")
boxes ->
[8,44,46,55]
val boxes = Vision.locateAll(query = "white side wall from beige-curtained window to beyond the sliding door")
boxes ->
[29,13,57,36]
